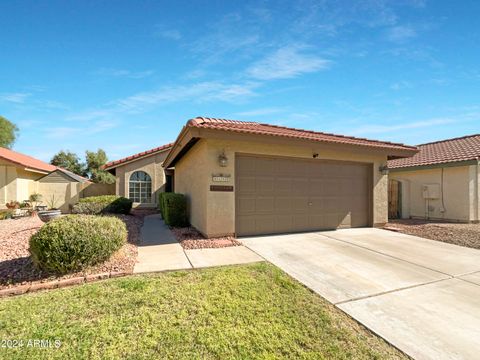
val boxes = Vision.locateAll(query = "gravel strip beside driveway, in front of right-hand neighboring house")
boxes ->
[387,219,480,249]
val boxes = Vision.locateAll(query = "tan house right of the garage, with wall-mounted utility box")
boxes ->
[388,134,480,222]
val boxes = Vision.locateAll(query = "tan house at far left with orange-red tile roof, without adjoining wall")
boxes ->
[0,147,57,207]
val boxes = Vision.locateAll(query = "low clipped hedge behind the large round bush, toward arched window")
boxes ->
[72,195,133,215]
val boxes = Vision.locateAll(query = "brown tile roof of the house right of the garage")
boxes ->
[388,134,480,169]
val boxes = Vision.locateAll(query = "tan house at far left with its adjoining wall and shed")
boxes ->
[0,147,92,212]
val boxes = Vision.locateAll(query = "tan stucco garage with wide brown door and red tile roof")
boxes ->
[162,117,417,237]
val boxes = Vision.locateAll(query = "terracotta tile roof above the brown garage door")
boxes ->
[187,117,416,150]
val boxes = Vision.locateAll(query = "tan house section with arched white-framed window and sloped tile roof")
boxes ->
[104,144,173,207]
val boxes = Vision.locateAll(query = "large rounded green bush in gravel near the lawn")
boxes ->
[29,215,127,274]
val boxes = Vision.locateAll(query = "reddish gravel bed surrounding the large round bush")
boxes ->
[0,211,151,289]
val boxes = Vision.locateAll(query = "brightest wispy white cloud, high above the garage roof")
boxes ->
[247,46,331,80]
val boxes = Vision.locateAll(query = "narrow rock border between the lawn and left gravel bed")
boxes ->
[0,271,133,298]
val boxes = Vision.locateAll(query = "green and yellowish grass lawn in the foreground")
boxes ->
[0,263,403,359]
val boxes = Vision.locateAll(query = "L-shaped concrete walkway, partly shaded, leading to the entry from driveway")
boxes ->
[133,214,263,273]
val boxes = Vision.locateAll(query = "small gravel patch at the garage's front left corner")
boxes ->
[171,227,241,250]
